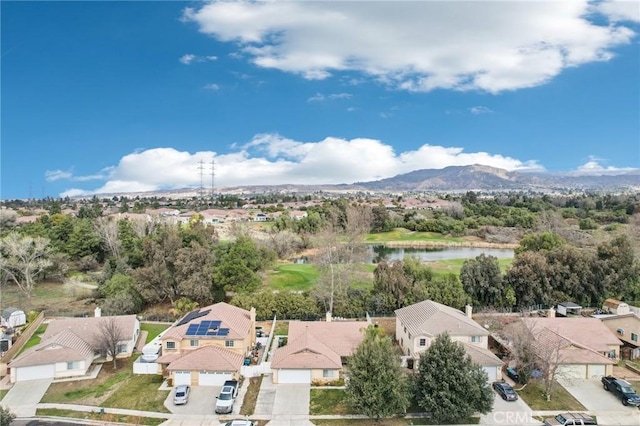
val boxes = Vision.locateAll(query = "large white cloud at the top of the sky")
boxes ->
[183,0,637,93]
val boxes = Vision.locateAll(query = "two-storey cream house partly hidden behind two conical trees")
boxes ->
[396,300,503,382]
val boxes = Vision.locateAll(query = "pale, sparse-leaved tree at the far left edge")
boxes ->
[0,232,52,299]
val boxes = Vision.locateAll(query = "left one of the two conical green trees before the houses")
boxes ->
[346,326,409,420]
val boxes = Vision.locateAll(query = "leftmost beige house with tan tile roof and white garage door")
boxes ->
[8,308,140,383]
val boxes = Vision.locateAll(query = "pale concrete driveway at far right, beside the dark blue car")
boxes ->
[558,379,638,412]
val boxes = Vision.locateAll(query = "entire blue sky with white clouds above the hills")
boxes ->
[0,0,640,199]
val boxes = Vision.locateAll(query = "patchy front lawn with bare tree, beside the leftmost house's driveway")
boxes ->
[42,358,169,413]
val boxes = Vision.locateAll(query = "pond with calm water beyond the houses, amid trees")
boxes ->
[369,244,513,263]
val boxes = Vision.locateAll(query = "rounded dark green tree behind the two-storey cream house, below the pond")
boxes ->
[460,253,504,307]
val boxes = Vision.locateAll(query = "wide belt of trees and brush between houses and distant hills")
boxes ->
[0,193,640,318]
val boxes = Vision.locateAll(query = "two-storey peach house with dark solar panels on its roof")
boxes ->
[156,302,256,386]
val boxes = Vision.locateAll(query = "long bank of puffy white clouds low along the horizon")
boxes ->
[52,134,543,196]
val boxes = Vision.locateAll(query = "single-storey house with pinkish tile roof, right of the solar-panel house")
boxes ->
[271,313,370,383]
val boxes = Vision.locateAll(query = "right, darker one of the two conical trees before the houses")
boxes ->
[415,333,493,424]
